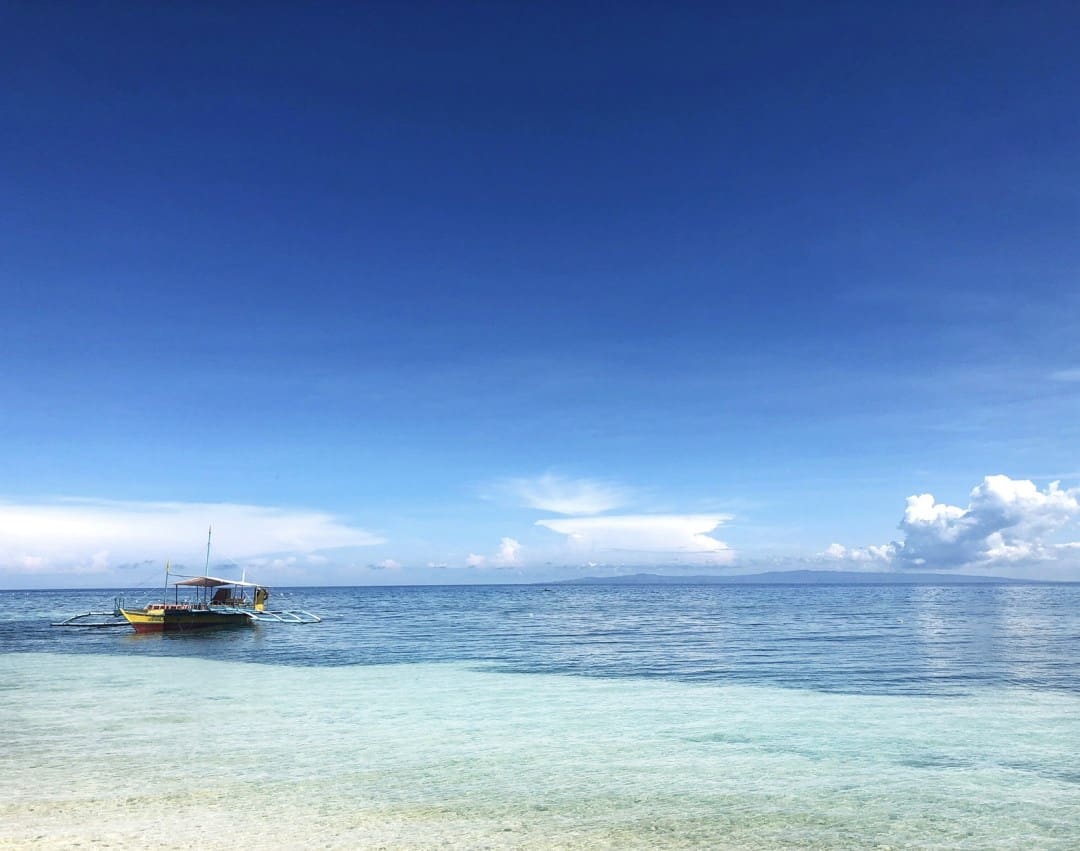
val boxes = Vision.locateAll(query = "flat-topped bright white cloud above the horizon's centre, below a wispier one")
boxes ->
[537,514,733,564]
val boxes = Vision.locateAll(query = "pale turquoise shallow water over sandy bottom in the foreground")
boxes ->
[0,653,1080,849]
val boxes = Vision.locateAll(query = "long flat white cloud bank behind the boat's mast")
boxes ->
[0,499,384,572]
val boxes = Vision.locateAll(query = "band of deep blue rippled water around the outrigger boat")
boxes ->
[0,584,1080,695]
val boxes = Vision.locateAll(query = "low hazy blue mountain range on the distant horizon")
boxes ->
[559,570,1045,585]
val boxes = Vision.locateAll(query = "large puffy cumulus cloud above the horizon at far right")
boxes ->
[822,475,1080,569]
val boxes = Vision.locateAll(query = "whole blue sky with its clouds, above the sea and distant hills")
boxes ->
[0,2,1080,586]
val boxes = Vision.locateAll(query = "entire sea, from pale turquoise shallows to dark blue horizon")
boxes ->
[0,584,1080,849]
